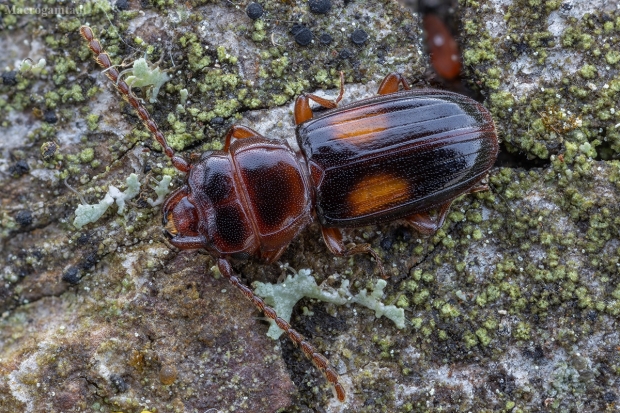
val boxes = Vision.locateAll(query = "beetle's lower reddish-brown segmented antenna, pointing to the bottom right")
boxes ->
[217,258,346,402]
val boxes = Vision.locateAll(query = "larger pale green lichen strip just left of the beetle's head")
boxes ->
[73,174,140,229]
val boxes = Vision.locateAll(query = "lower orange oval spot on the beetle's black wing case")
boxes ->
[348,173,411,216]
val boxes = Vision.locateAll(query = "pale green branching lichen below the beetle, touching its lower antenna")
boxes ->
[253,269,405,340]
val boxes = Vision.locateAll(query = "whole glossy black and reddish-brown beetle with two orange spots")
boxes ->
[80,26,498,401]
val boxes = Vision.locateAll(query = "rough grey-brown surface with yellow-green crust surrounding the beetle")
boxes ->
[0,0,620,412]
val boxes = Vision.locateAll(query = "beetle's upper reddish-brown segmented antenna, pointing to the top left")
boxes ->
[80,26,191,172]
